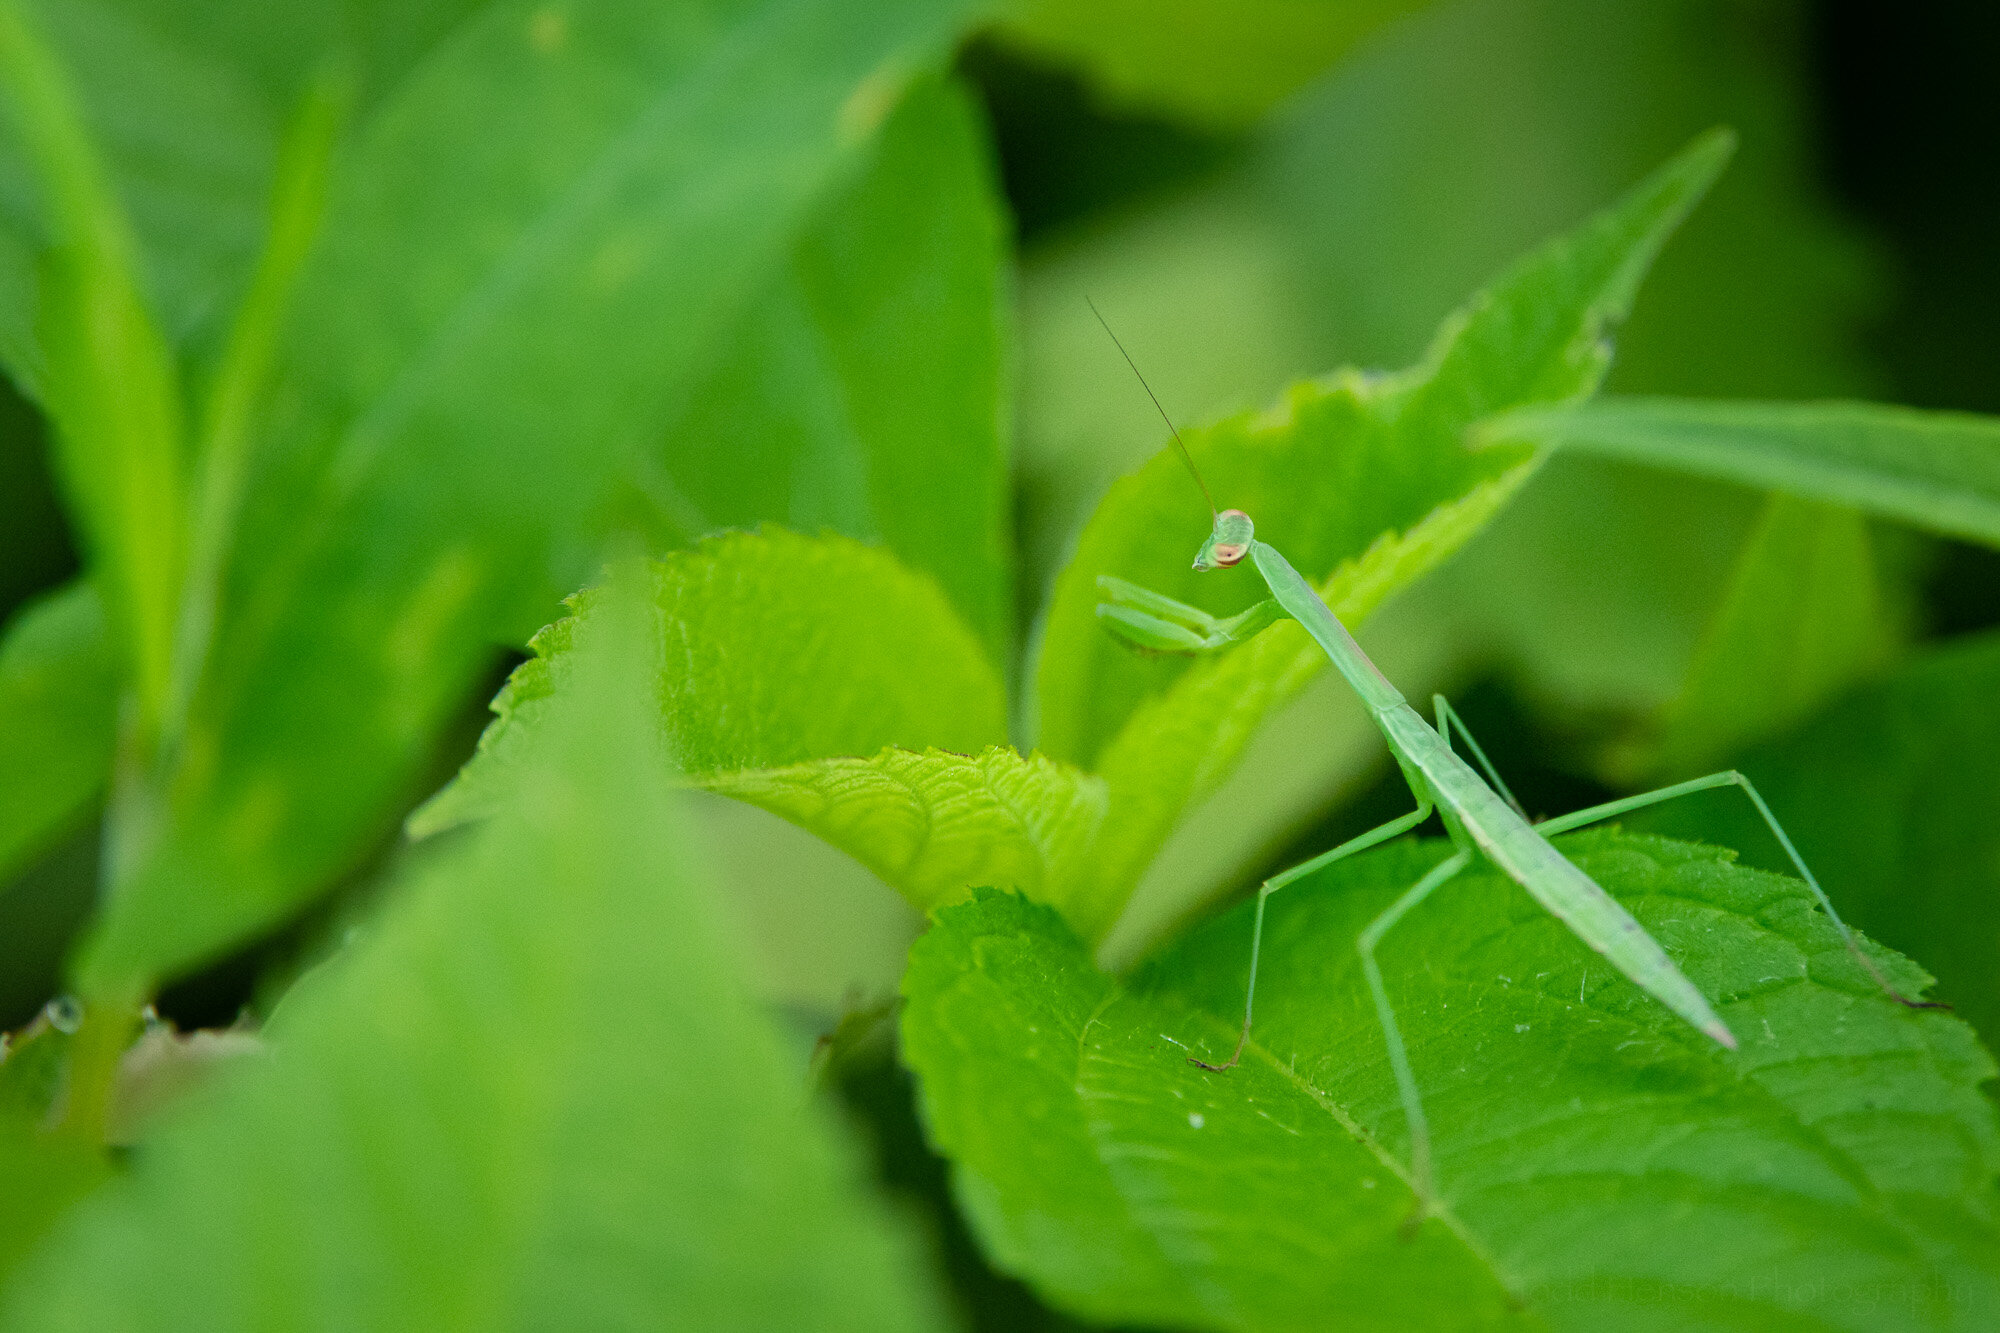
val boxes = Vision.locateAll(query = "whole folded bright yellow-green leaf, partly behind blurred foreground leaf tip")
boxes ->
[410,528,1136,923]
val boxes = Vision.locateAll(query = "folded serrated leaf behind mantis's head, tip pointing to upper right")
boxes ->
[1038,124,1730,925]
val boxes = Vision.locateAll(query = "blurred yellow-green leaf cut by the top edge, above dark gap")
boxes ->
[998,0,1426,126]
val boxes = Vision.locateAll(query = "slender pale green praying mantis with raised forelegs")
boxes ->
[1092,304,1946,1213]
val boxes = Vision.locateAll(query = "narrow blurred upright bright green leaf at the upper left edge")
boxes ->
[0,0,186,733]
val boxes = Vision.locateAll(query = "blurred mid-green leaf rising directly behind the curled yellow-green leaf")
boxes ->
[642,78,1012,660]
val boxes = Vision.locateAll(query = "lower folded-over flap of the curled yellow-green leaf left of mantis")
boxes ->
[702,747,1104,923]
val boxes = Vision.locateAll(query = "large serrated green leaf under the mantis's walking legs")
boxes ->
[904,833,2000,1329]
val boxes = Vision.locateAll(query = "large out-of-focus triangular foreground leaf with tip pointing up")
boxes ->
[6,564,938,1333]
